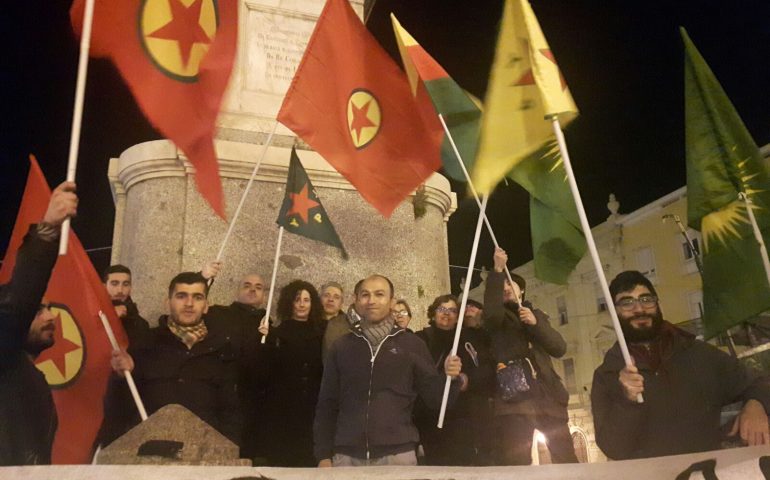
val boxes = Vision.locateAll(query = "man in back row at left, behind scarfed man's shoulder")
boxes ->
[102,264,150,345]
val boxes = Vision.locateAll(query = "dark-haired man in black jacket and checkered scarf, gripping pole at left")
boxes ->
[105,272,241,443]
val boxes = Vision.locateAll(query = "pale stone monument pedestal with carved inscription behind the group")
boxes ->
[108,0,456,328]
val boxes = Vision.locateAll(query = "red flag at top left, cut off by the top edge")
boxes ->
[70,0,238,218]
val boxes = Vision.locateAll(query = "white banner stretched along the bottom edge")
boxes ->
[6,447,770,480]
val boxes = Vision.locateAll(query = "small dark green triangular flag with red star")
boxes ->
[276,148,348,258]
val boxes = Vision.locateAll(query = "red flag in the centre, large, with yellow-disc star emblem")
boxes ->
[278,0,443,217]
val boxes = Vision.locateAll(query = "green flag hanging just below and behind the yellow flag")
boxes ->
[508,140,586,285]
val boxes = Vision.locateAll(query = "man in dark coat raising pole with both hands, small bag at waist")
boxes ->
[483,248,577,465]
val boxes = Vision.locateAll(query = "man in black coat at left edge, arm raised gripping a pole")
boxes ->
[0,182,78,465]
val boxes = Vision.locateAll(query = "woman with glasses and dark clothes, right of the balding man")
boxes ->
[417,295,494,465]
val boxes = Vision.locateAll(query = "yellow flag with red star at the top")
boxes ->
[472,0,578,193]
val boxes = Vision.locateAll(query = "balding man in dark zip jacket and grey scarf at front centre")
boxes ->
[313,275,462,467]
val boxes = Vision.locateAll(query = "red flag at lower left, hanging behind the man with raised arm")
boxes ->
[0,157,127,464]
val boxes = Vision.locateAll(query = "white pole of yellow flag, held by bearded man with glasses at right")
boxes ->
[551,115,644,403]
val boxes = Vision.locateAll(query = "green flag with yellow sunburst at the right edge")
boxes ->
[681,28,770,338]
